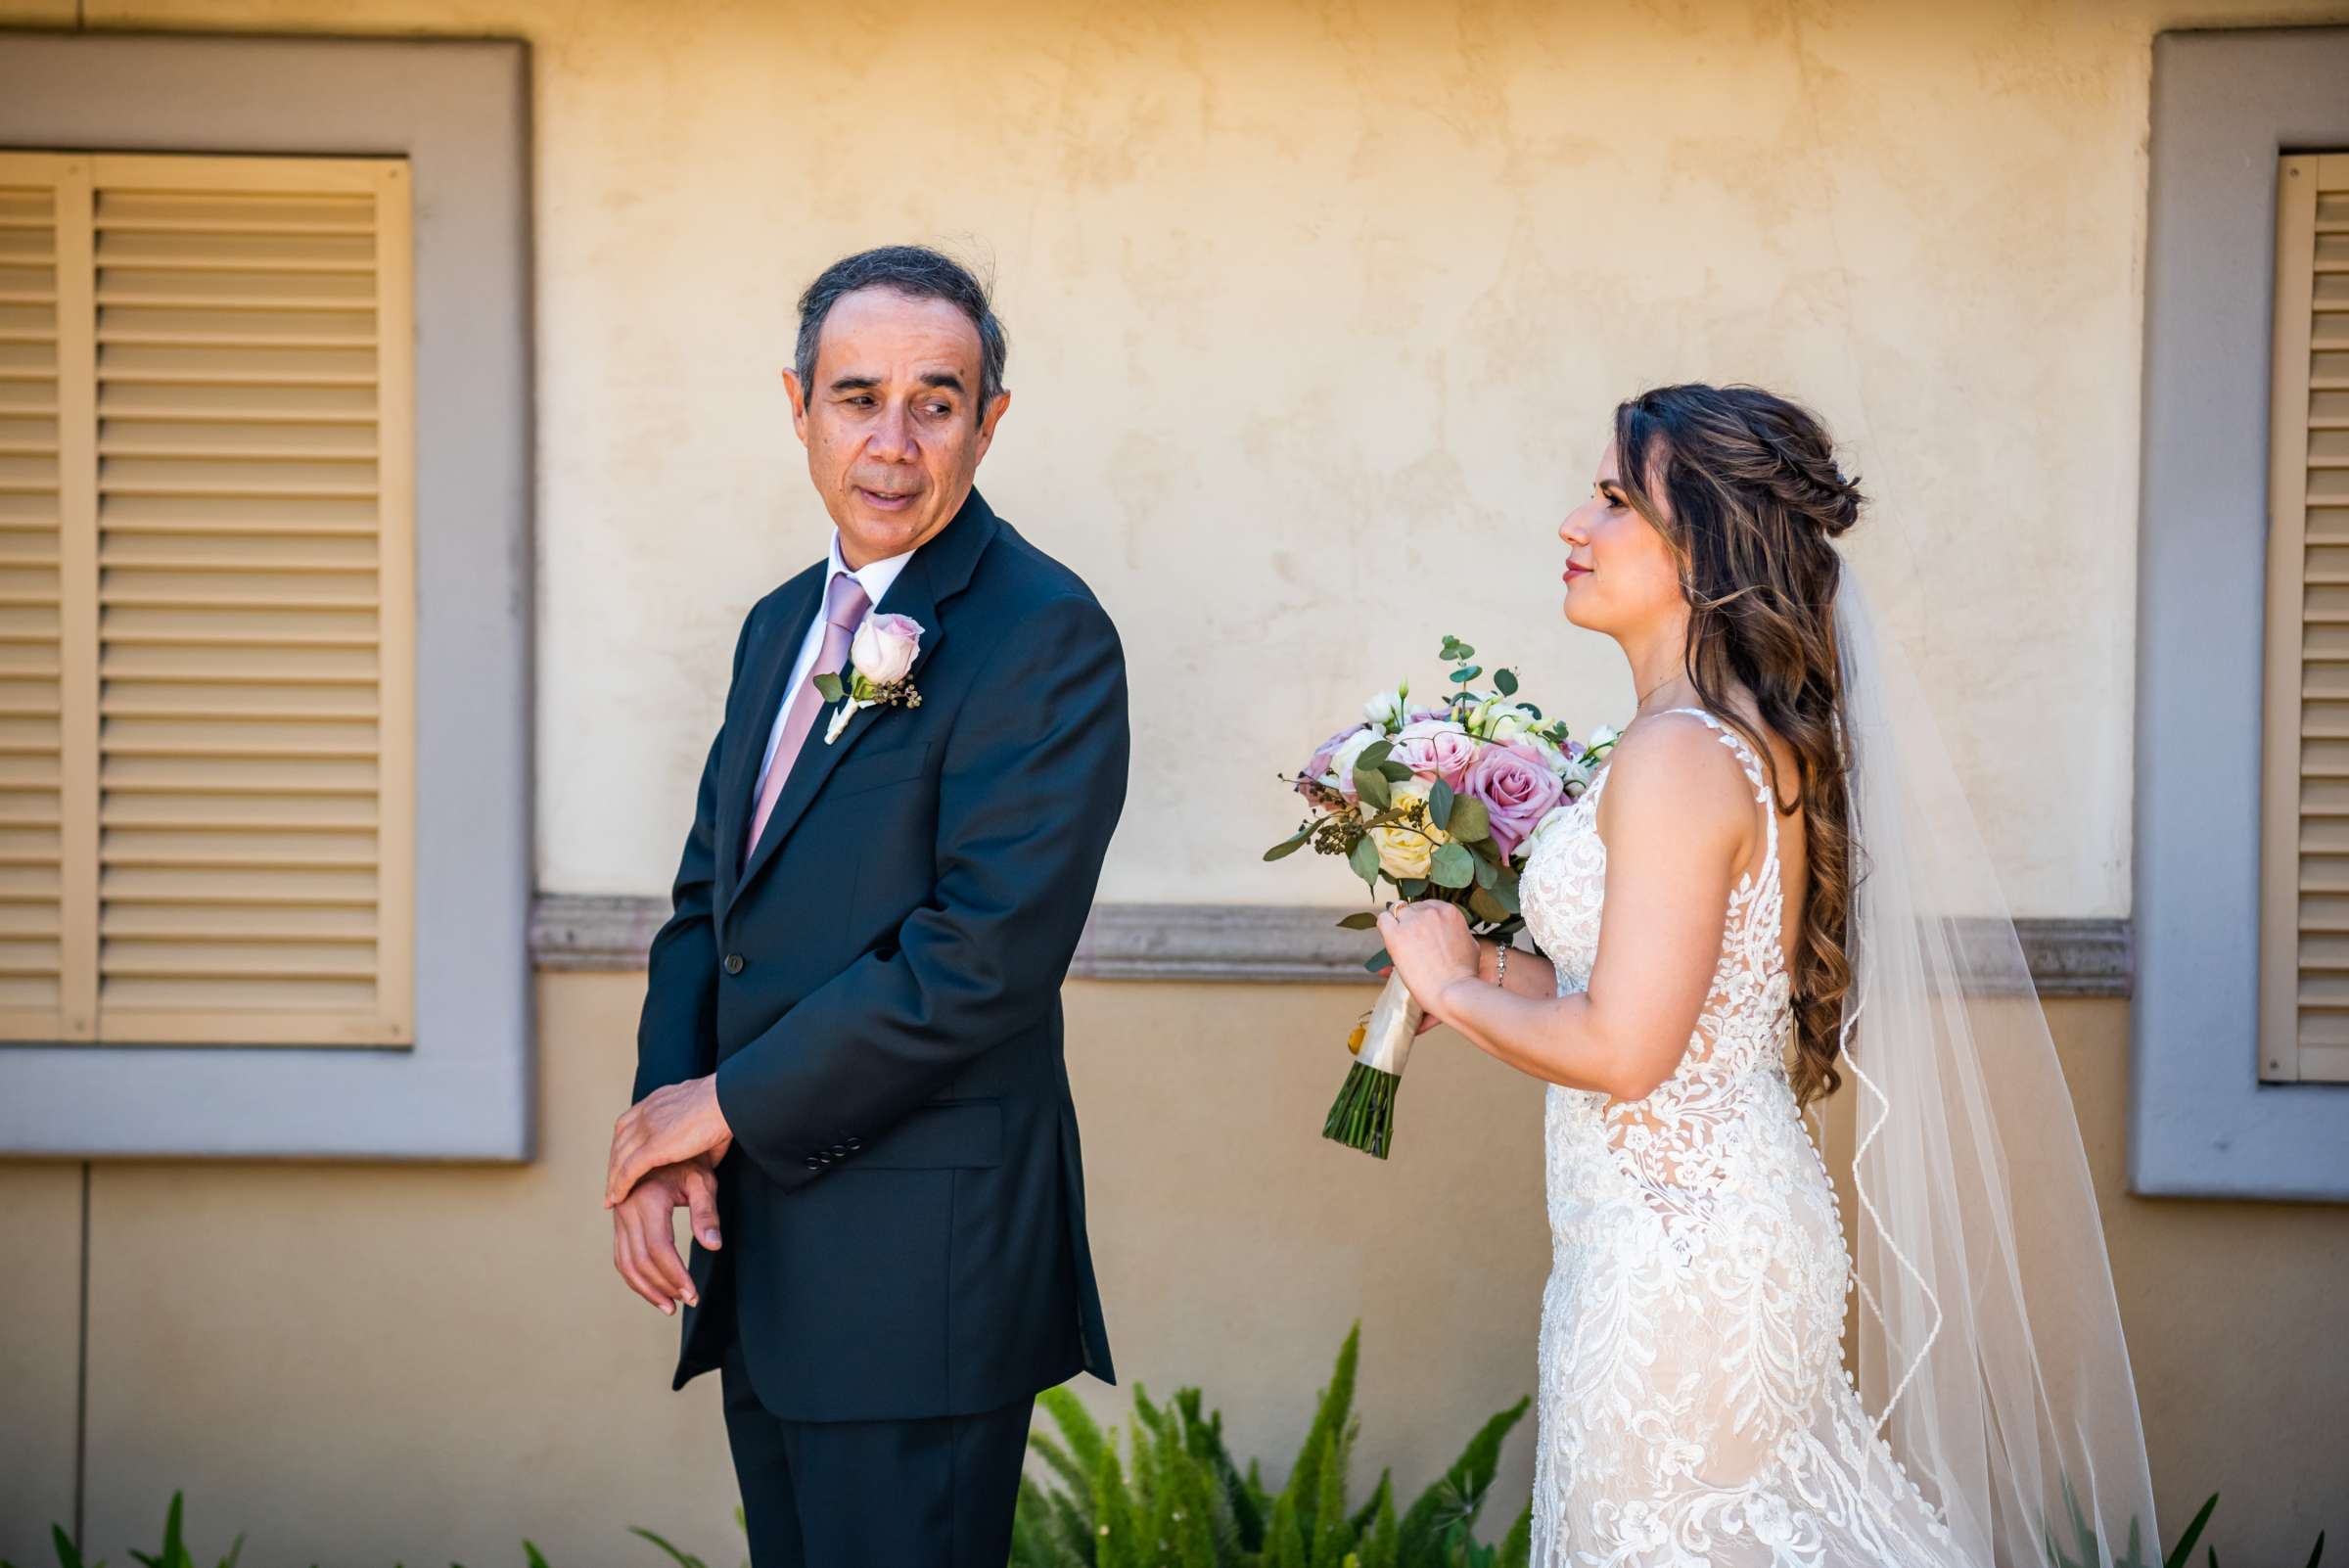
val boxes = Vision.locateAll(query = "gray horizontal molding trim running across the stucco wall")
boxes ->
[530,892,2133,997]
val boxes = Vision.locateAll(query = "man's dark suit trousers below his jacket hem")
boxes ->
[718,1336,1036,1568]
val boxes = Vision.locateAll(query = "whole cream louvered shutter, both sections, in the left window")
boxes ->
[0,155,416,1044]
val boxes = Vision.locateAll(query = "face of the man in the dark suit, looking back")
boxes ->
[782,289,1012,566]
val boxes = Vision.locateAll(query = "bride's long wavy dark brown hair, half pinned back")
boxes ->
[1614,383,1865,1103]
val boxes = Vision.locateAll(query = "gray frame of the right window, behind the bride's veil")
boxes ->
[2128,28,2349,1202]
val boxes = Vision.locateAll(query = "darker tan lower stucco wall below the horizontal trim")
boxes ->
[0,974,2349,1568]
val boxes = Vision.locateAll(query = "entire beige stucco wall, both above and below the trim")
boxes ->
[0,0,2349,1568]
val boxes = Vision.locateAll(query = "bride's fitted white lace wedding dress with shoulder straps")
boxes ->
[1520,709,1961,1568]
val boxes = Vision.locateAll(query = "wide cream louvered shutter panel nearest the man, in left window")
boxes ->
[89,155,413,1044]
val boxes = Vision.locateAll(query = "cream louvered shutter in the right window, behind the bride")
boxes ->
[2260,153,2349,1083]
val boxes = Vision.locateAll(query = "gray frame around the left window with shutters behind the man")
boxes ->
[0,30,535,1160]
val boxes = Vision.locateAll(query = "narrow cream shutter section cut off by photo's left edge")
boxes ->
[0,153,96,1039]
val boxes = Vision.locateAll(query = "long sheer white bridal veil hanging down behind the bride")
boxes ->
[1834,559,2161,1568]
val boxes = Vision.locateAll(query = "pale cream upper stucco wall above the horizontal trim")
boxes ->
[0,0,2349,915]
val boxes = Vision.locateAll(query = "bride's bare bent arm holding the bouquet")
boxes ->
[1379,715,1757,1101]
